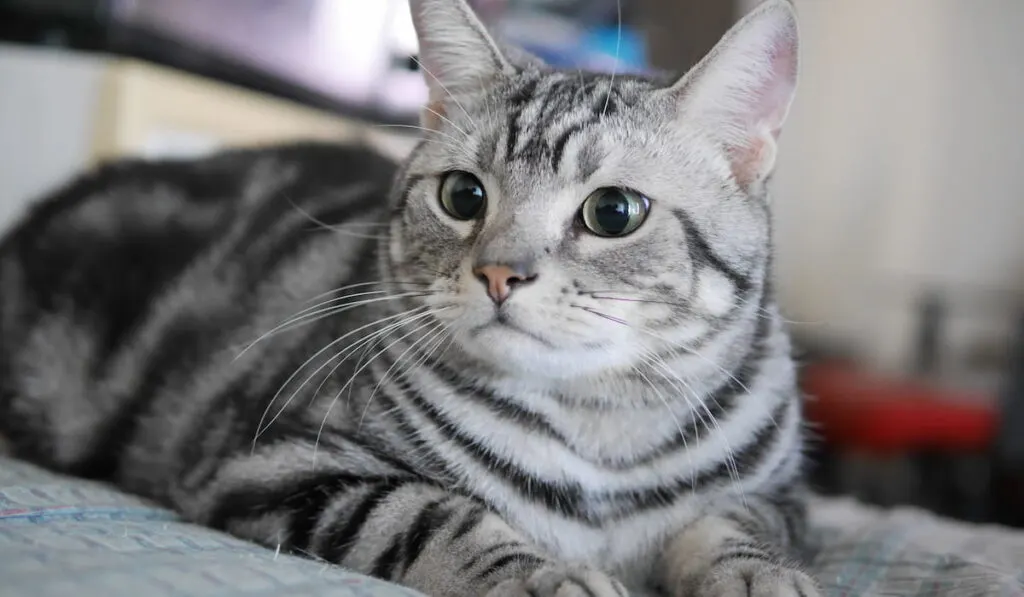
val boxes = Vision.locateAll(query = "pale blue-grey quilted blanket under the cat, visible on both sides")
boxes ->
[0,458,1024,597]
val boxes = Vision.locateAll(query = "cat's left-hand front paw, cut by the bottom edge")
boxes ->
[487,564,629,597]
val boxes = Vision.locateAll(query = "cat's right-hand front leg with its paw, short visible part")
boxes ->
[657,492,821,597]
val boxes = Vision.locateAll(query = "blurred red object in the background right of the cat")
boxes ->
[802,363,997,453]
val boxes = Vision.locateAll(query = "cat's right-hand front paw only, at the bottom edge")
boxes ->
[697,560,821,597]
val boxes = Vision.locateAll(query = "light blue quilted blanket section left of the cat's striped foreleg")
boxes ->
[0,459,419,597]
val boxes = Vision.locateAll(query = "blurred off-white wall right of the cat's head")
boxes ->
[742,0,1024,376]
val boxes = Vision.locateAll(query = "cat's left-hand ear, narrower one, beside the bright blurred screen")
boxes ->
[407,0,513,128]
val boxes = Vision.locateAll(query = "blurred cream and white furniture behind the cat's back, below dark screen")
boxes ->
[0,44,416,229]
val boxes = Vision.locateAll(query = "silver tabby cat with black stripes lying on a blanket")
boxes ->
[0,0,820,597]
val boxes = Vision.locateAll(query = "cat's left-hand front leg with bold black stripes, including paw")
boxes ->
[174,437,626,597]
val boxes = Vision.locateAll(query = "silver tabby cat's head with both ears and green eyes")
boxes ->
[387,0,798,377]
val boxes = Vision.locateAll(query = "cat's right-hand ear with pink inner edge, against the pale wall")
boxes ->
[670,0,799,187]
